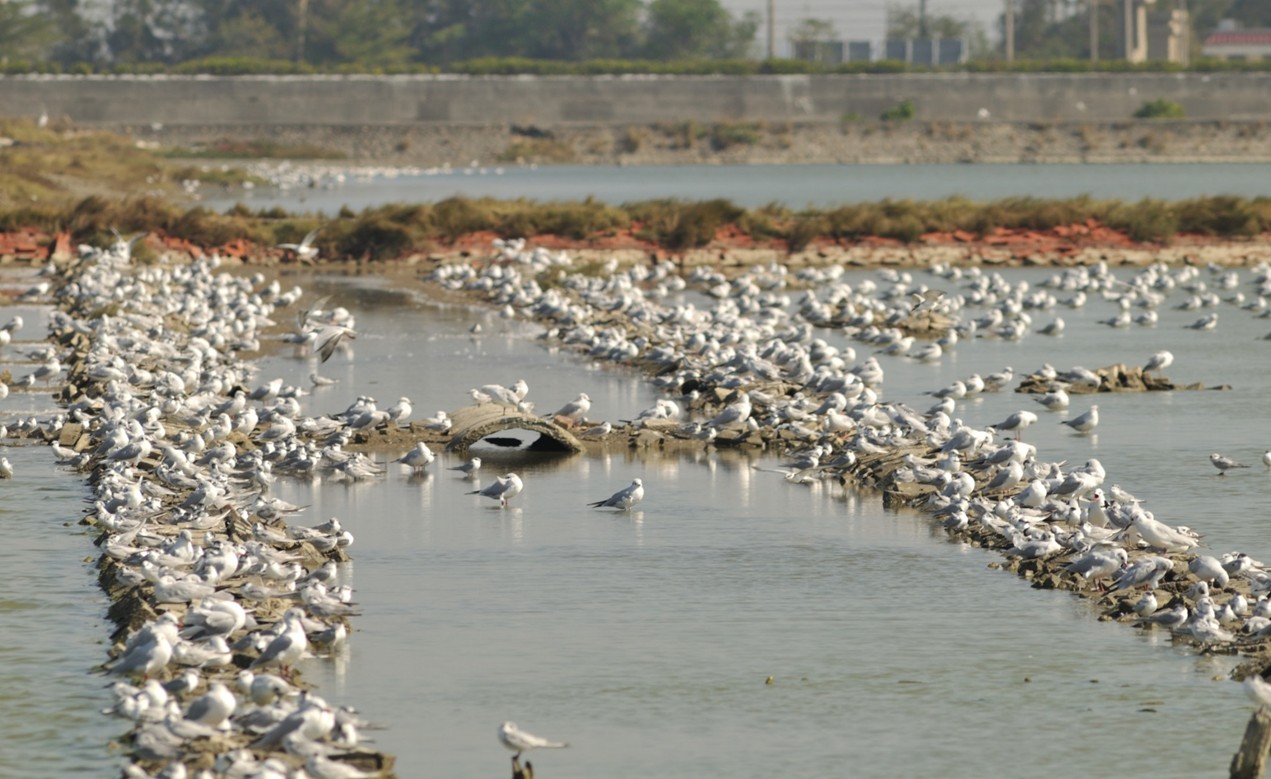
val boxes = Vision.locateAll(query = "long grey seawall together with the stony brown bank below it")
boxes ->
[0,72,1271,166]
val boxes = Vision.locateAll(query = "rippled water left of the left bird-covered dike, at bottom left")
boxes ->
[0,446,122,776]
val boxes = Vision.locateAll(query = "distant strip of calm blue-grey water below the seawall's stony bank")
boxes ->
[207,163,1271,215]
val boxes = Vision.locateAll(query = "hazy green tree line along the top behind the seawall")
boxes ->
[0,0,1271,72]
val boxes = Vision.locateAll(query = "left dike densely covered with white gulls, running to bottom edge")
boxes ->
[50,243,393,776]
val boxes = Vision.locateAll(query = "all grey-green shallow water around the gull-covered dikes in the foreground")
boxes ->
[0,254,1271,778]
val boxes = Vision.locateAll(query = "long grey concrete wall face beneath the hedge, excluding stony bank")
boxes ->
[0,72,1271,127]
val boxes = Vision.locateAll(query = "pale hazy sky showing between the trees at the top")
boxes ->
[719,0,1005,56]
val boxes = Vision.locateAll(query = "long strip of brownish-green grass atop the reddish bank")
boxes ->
[0,188,1271,259]
